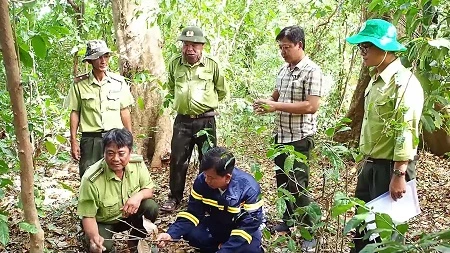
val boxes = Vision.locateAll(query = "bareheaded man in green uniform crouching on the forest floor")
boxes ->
[77,128,158,253]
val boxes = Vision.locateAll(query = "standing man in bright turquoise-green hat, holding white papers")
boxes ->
[347,19,424,252]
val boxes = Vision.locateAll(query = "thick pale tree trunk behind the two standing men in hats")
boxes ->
[112,0,172,168]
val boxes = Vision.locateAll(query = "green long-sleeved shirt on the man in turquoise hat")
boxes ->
[360,59,424,161]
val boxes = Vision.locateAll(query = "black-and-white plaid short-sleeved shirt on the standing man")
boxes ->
[276,56,325,143]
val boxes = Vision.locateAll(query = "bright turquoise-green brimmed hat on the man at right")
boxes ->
[346,19,406,52]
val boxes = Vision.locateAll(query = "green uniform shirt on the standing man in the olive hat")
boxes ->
[168,55,228,115]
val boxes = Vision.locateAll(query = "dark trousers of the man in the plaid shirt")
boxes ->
[275,136,314,226]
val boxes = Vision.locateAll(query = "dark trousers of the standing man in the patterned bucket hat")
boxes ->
[78,136,103,178]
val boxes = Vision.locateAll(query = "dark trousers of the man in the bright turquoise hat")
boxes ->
[352,158,416,252]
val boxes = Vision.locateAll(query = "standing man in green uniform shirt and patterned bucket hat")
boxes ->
[66,40,134,177]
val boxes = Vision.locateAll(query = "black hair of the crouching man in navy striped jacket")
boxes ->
[200,147,235,177]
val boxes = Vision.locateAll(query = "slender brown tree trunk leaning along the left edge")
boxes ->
[0,0,44,253]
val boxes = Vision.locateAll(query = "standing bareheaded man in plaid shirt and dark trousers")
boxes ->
[253,26,325,251]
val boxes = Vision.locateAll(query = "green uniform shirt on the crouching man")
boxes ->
[77,155,155,223]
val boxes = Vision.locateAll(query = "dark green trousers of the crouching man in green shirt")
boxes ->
[85,199,158,253]
